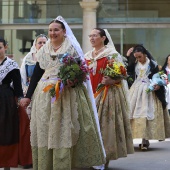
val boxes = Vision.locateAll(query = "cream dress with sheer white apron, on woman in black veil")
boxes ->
[129,59,170,140]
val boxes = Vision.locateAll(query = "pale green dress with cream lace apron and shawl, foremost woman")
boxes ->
[31,38,105,170]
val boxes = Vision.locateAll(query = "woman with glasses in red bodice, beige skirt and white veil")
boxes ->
[85,28,134,169]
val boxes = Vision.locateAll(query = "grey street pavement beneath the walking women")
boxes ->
[0,138,170,170]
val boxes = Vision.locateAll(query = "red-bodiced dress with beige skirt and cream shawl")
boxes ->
[85,46,134,161]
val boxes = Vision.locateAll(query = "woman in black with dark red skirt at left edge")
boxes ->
[0,38,32,167]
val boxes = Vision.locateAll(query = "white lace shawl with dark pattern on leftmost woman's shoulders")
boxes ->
[0,57,19,84]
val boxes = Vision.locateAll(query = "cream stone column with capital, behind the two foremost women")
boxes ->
[80,0,99,53]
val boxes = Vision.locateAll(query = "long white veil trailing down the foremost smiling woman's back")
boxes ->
[55,16,106,155]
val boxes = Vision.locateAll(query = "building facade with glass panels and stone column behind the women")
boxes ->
[0,0,170,64]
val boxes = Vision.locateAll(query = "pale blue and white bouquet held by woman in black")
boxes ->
[146,71,167,93]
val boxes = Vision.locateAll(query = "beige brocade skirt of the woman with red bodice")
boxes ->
[96,83,134,160]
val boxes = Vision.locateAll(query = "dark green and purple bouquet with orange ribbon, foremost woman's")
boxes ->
[44,53,88,100]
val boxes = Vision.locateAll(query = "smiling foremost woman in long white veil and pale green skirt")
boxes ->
[20,16,105,170]
